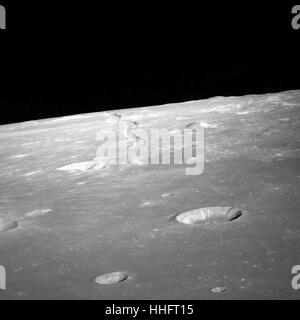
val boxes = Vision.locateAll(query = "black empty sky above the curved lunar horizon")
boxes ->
[0,0,300,124]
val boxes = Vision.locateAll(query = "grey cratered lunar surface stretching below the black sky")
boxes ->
[0,91,300,300]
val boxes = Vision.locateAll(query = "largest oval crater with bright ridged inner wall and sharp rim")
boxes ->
[175,207,243,224]
